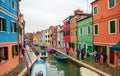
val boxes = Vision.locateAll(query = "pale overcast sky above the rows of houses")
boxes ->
[20,0,94,32]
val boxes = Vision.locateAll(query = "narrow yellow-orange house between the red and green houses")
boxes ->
[70,9,89,50]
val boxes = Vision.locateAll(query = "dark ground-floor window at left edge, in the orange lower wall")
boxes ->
[0,47,8,63]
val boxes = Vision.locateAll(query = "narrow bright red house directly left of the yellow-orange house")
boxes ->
[63,16,71,47]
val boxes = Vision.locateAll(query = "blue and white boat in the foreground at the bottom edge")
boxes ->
[30,59,48,76]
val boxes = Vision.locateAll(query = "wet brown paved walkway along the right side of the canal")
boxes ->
[58,49,120,76]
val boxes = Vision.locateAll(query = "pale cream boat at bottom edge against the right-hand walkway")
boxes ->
[80,67,100,76]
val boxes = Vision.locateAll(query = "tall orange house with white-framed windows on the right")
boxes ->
[92,0,120,68]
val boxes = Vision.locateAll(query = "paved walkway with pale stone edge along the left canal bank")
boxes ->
[2,45,37,76]
